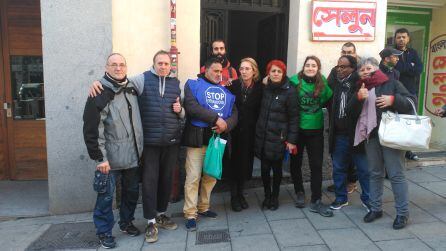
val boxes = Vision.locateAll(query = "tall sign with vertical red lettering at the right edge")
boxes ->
[424,34,446,114]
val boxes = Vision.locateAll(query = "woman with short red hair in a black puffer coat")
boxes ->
[255,60,299,210]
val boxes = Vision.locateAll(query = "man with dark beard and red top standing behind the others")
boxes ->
[200,39,238,86]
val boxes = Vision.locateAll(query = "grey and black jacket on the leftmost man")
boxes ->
[83,78,143,170]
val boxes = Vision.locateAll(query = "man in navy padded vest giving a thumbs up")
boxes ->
[87,50,185,243]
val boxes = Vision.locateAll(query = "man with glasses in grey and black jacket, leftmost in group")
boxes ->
[83,53,143,248]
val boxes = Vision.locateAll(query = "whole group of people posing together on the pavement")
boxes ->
[84,29,430,248]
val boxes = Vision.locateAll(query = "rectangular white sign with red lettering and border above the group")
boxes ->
[311,1,376,41]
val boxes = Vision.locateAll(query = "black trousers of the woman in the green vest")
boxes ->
[290,129,324,202]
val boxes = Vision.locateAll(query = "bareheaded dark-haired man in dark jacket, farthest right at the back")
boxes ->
[393,28,423,160]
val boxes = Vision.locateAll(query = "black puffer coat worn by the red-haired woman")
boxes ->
[255,78,299,160]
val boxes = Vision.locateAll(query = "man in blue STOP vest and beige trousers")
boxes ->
[182,58,237,231]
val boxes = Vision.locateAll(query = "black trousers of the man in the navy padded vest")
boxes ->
[142,145,179,219]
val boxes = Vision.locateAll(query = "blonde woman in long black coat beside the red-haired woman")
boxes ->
[227,58,262,212]
